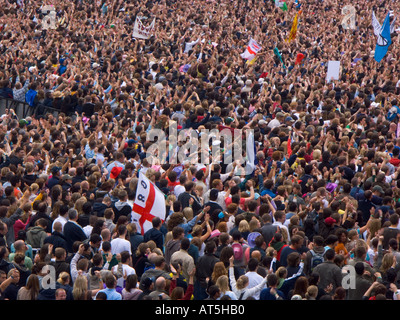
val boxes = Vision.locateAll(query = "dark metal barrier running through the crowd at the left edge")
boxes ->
[0,97,60,119]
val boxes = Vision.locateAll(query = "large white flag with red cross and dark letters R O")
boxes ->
[132,171,166,235]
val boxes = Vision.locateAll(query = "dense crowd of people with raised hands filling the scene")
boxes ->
[0,0,400,300]
